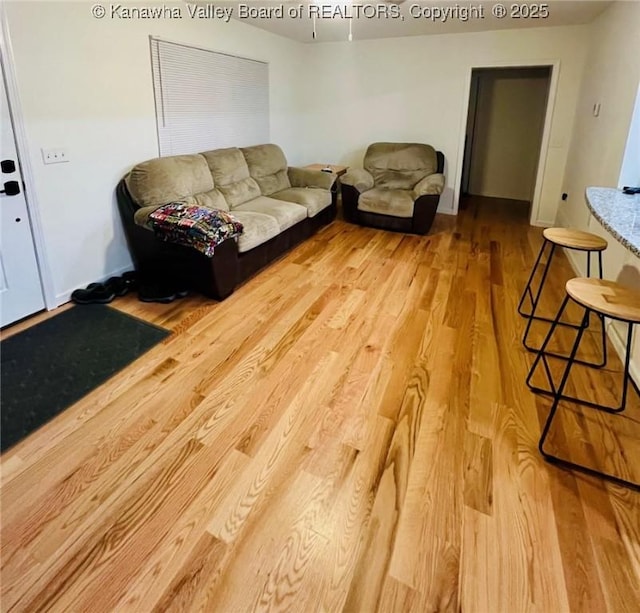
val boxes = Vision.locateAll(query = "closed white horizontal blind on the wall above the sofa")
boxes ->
[151,38,269,156]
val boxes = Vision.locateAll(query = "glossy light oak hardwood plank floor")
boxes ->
[1,199,640,613]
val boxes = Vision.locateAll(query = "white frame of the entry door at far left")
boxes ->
[0,5,58,311]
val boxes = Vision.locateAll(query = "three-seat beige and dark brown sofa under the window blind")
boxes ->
[117,144,336,299]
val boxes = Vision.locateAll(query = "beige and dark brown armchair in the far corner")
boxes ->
[340,143,445,234]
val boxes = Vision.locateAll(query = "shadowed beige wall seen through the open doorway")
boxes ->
[469,68,550,202]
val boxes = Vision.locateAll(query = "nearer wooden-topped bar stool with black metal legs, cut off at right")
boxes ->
[527,278,640,490]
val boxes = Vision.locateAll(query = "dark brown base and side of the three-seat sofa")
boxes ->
[116,181,336,300]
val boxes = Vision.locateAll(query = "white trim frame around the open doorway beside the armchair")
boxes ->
[453,60,560,226]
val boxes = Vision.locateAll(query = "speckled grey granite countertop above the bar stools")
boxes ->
[587,187,640,257]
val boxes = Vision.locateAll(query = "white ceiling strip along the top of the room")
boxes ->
[219,0,611,43]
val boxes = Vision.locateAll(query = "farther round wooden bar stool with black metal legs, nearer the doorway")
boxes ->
[518,228,607,368]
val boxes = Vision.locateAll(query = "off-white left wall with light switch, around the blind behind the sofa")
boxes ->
[5,2,306,303]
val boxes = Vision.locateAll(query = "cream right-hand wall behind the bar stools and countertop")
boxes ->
[557,2,640,382]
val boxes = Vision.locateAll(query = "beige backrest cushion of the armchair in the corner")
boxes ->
[364,143,438,189]
